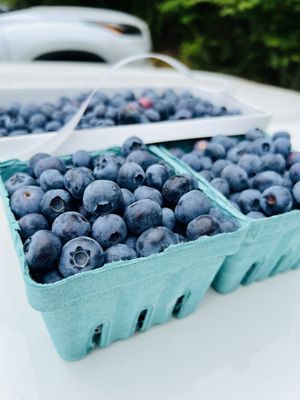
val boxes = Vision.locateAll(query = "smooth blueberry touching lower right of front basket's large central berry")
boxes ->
[124,199,162,234]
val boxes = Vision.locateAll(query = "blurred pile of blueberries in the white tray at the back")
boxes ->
[0,89,240,137]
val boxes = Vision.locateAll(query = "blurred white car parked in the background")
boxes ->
[0,7,151,63]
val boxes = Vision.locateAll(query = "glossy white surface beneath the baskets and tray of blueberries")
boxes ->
[0,64,300,400]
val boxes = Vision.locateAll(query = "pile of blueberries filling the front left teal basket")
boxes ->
[5,137,238,283]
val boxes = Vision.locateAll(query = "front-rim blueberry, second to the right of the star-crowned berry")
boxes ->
[136,226,179,257]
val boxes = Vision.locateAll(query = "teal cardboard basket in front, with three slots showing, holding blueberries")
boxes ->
[0,146,248,360]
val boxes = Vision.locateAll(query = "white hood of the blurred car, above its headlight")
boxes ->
[0,7,147,28]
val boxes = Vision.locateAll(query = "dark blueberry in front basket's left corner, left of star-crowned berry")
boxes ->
[24,230,61,272]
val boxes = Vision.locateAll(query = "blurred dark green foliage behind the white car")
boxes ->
[7,0,300,89]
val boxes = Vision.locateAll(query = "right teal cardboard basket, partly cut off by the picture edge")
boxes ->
[160,146,300,293]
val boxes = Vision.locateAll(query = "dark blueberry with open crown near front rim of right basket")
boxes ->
[260,186,293,215]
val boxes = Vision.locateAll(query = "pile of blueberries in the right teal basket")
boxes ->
[171,128,300,218]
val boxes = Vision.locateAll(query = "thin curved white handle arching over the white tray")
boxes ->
[17,53,218,160]
